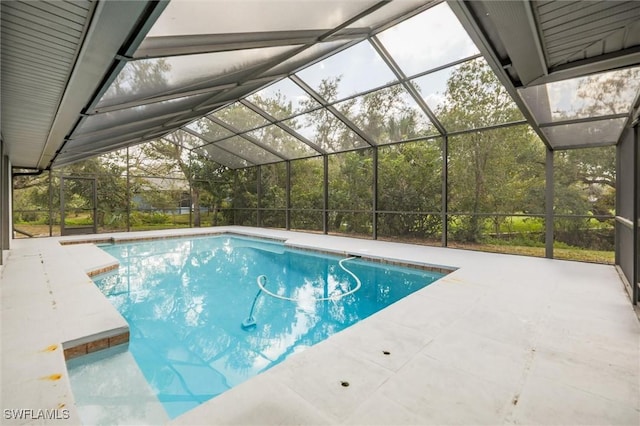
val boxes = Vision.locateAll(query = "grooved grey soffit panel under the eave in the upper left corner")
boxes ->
[0,1,93,167]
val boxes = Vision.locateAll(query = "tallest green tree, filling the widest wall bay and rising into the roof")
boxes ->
[438,60,545,242]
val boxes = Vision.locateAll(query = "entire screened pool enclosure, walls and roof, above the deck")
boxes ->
[1,0,640,303]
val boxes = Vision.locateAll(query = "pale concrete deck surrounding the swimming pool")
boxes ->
[0,227,640,425]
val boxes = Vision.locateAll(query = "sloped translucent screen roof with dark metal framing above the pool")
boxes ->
[55,0,639,168]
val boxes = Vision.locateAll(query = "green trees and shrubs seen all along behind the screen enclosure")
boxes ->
[13,55,626,258]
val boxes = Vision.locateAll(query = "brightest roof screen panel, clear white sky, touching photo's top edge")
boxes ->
[378,3,478,76]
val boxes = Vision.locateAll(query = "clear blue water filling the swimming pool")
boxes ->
[72,236,442,418]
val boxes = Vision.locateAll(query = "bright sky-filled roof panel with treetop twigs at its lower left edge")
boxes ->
[296,41,395,102]
